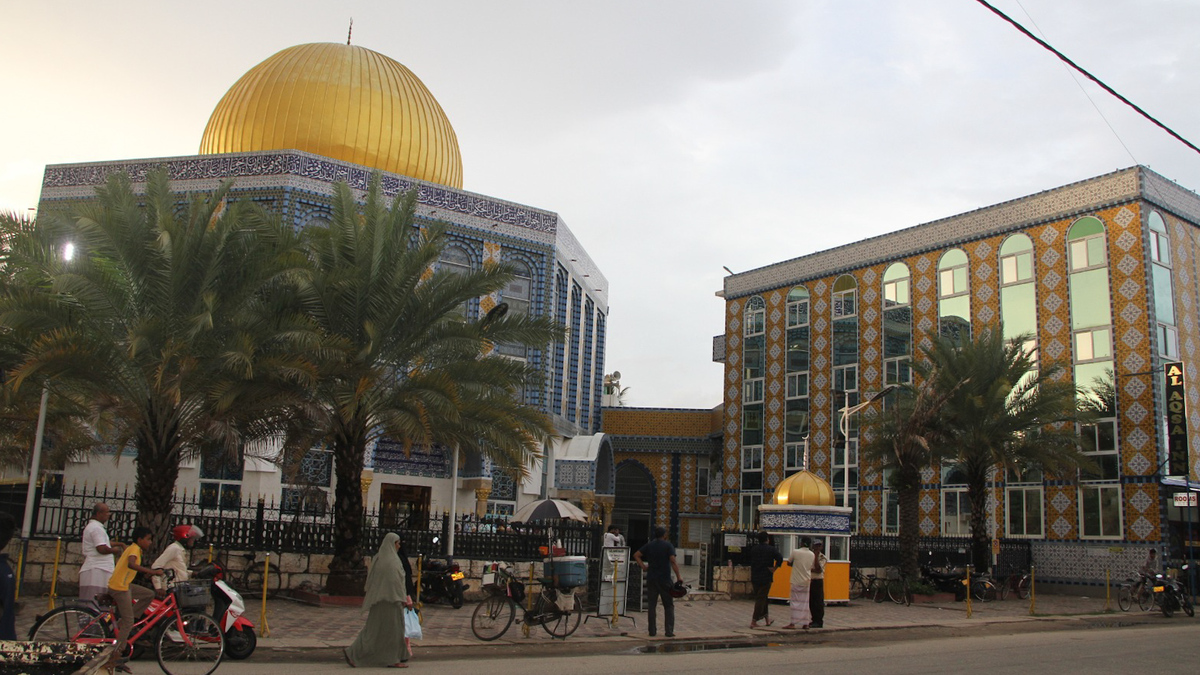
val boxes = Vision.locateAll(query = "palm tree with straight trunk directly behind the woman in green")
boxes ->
[298,175,562,593]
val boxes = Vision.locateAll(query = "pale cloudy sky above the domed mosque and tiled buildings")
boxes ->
[0,0,1200,408]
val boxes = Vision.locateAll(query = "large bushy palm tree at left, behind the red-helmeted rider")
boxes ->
[0,171,316,540]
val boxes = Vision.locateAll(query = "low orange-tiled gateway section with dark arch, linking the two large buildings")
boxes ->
[601,407,722,549]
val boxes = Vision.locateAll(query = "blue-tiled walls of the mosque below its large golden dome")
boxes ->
[41,150,611,515]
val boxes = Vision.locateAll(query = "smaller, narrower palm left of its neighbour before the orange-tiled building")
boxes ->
[859,371,954,579]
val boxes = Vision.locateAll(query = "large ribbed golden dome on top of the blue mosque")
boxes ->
[200,43,462,187]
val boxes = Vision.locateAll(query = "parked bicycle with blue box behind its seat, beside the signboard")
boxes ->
[470,566,583,641]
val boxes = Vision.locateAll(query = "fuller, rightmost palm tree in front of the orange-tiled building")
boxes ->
[924,328,1091,572]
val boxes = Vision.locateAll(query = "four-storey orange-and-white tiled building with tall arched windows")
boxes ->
[714,167,1200,580]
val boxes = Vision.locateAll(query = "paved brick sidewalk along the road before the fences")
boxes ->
[17,595,1145,652]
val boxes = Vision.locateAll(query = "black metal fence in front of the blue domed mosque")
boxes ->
[11,485,602,562]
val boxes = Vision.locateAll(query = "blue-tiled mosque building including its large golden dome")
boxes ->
[32,43,612,515]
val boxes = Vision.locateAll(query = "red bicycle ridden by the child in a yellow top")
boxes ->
[29,571,224,675]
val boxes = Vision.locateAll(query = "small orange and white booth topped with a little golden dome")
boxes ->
[758,471,853,604]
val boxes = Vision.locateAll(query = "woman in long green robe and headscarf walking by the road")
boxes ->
[342,532,415,668]
